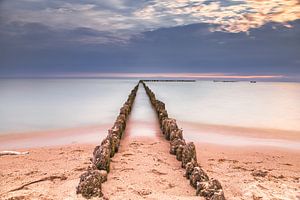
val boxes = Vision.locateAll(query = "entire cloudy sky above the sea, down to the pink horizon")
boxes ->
[0,0,300,81]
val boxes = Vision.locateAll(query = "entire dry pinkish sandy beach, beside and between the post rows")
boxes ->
[0,123,300,200]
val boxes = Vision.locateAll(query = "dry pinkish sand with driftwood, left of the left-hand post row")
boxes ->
[0,145,94,200]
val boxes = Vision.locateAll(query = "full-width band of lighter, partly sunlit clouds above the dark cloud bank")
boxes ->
[0,0,300,42]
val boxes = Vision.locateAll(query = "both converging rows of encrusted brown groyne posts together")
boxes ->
[77,81,225,200]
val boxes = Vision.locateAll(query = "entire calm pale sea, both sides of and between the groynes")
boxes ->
[0,79,300,134]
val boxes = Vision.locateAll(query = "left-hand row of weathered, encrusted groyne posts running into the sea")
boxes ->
[76,85,139,198]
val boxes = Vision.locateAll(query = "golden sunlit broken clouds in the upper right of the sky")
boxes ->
[135,0,300,33]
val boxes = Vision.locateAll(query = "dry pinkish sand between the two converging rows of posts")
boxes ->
[103,137,202,200]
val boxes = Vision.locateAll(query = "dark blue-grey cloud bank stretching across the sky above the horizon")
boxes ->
[0,20,300,81]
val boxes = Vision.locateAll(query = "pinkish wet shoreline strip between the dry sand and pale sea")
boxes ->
[0,121,300,151]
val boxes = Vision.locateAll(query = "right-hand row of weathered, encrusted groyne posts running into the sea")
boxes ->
[141,81,225,200]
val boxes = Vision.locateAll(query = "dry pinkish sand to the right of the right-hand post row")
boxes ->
[196,143,300,200]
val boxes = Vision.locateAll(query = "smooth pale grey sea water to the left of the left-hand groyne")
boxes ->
[0,79,138,134]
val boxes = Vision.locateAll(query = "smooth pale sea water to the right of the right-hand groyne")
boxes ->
[147,81,300,131]
